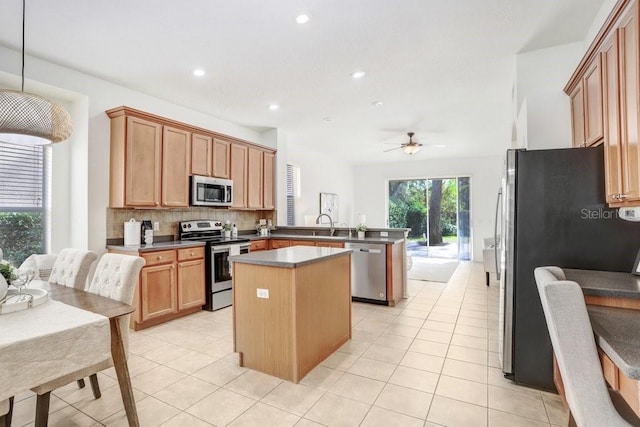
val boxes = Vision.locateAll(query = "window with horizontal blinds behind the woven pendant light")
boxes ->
[0,142,47,266]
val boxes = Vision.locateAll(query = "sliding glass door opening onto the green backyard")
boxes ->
[388,177,471,280]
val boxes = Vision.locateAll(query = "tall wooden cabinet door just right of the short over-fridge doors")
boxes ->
[601,31,623,203]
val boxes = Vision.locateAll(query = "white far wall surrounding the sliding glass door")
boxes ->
[354,155,502,261]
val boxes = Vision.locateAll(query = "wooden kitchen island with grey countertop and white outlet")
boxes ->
[229,246,351,383]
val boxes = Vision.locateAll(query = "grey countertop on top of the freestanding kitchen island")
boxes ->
[229,246,351,268]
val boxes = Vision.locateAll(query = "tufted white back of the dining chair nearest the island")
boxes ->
[86,253,145,350]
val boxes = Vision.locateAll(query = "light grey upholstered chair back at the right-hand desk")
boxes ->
[534,267,630,427]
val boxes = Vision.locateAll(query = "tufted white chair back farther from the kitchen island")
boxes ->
[49,248,98,290]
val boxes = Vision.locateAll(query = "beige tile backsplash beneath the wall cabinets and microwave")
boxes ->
[107,207,276,239]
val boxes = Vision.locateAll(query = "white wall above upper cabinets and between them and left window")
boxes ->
[0,46,268,253]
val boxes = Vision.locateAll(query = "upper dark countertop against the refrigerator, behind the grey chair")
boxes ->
[562,268,640,299]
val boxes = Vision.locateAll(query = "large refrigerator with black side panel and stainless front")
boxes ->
[497,146,640,390]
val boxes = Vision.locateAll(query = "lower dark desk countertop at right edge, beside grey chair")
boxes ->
[587,305,640,380]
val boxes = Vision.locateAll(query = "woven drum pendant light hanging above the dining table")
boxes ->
[0,0,73,145]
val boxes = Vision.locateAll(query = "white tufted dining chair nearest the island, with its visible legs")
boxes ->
[32,253,145,426]
